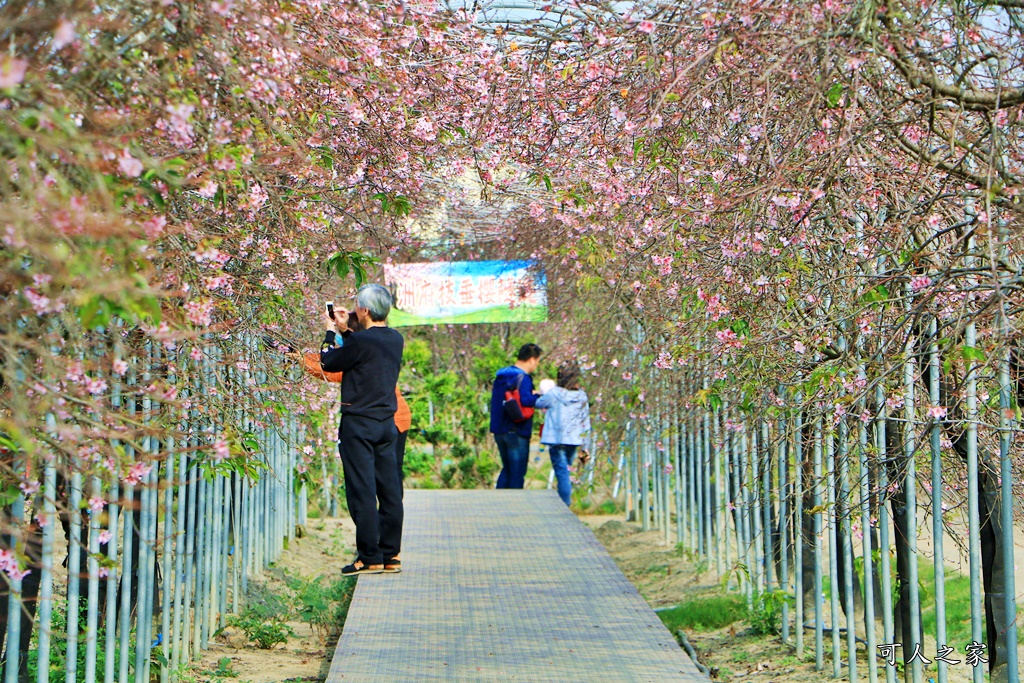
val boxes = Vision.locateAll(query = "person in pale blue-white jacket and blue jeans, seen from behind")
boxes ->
[537,362,590,505]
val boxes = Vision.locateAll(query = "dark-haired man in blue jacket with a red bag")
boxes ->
[490,344,541,488]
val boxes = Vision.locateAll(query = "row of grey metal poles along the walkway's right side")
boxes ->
[614,348,1019,683]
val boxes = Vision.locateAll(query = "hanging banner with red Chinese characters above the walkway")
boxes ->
[384,261,547,327]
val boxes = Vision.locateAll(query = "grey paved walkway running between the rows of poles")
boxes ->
[327,490,707,683]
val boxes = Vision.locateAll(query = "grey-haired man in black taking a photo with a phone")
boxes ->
[321,285,404,575]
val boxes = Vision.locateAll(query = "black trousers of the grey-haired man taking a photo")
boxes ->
[338,415,403,564]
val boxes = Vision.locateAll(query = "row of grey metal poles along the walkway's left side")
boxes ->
[0,342,306,683]
